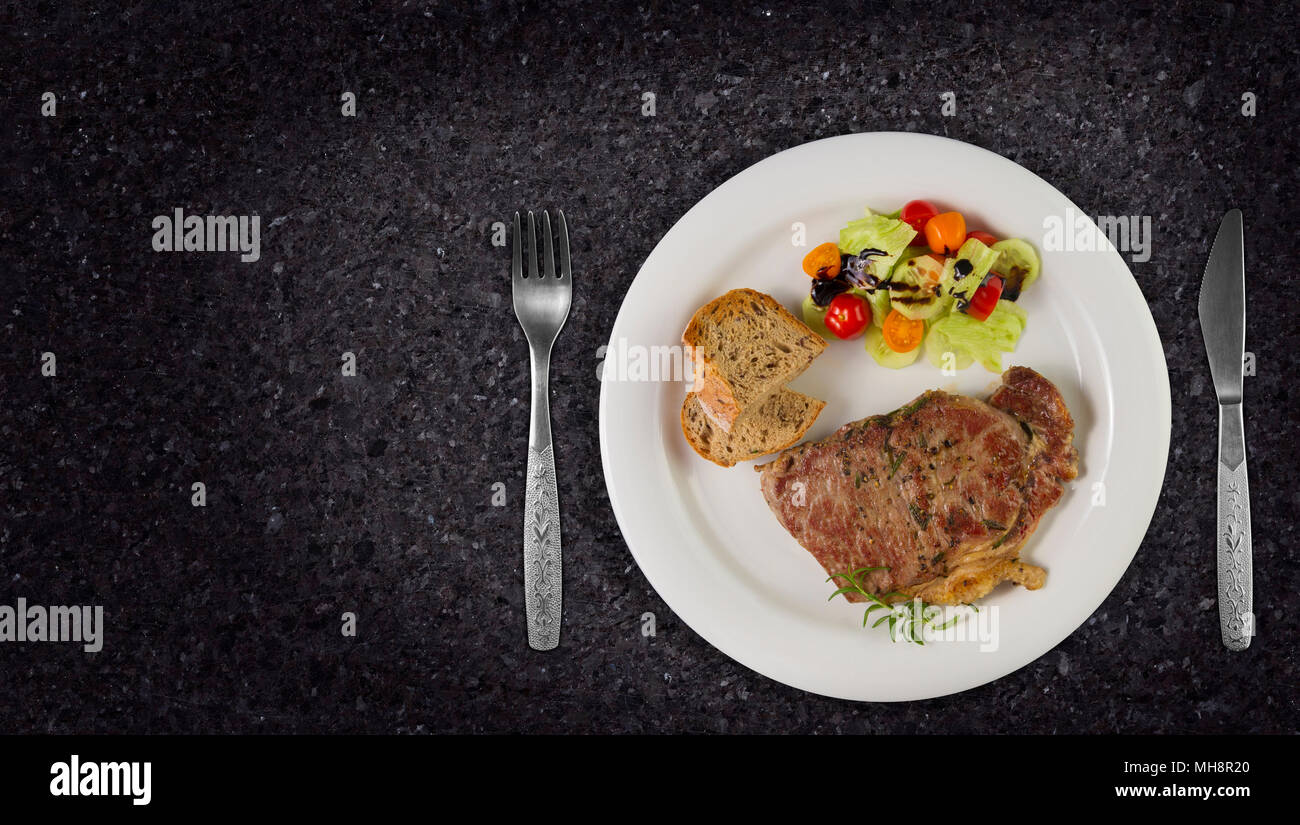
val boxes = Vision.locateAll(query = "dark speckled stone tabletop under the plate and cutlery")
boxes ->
[0,1,1300,734]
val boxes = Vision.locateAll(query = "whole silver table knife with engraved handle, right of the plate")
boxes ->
[1197,209,1255,651]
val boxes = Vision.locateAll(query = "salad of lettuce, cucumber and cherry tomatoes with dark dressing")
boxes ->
[803,200,1041,373]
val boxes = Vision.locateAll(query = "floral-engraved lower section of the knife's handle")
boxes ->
[1217,460,1255,651]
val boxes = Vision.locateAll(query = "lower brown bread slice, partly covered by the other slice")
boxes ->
[681,387,826,466]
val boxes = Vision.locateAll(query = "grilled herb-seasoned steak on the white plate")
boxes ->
[757,366,1078,604]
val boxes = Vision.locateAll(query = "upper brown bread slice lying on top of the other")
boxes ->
[681,290,826,433]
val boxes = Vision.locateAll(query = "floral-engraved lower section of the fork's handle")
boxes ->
[524,444,562,651]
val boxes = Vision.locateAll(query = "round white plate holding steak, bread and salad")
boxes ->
[601,133,1170,702]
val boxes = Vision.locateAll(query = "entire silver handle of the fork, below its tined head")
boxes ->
[524,352,562,651]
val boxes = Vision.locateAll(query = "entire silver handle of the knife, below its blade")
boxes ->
[1214,401,1255,651]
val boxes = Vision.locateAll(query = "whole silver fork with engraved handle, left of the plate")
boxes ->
[511,212,573,651]
